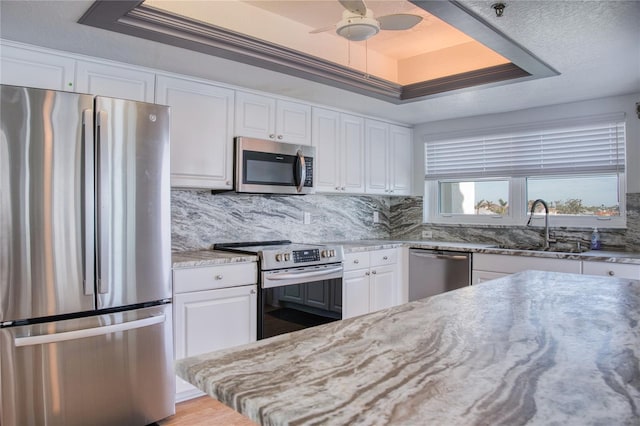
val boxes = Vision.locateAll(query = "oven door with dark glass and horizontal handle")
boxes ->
[258,263,342,339]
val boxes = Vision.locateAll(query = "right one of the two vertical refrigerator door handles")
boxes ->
[96,111,110,294]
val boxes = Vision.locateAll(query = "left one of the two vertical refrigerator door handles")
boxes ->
[82,109,96,296]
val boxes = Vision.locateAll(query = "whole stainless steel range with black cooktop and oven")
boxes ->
[214,240,344,339]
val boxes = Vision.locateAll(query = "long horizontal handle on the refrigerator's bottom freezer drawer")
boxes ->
[14,314,166,347]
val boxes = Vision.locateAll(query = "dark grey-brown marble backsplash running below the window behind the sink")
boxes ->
[390,193,640,252]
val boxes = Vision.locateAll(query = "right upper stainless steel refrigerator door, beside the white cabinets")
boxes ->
[95,97,171,309]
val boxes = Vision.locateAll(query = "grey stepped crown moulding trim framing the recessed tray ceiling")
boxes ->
[78,0,558,104]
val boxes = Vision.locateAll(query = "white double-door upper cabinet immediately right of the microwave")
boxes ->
[312,108,365,193]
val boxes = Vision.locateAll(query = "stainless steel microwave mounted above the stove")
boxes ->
[234,137,316,194]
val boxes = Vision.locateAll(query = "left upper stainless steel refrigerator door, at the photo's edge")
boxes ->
[0,85,94,322]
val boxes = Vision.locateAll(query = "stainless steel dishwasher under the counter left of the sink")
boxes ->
[409,249,471,302]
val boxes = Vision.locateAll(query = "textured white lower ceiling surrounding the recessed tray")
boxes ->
[0,0,640,124]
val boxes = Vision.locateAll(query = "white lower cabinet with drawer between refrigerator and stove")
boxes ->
[173,263,257,402]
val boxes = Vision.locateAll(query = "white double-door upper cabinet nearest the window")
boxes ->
[366,120,413,195]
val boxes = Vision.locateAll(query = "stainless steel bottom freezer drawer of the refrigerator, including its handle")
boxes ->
[0,304,175,426]
